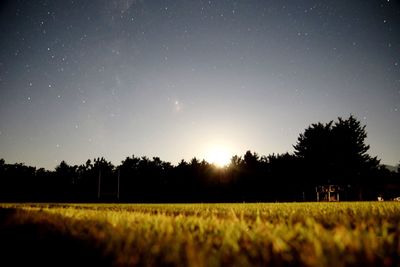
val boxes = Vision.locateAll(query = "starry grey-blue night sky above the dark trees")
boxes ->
[0,0,400,169]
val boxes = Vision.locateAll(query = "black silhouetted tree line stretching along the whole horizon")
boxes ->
[0,116,400,202]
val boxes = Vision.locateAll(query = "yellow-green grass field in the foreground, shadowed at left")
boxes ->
[0,202,400,266]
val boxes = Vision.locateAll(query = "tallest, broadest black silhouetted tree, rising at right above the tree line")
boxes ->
[294,115,379,201]
